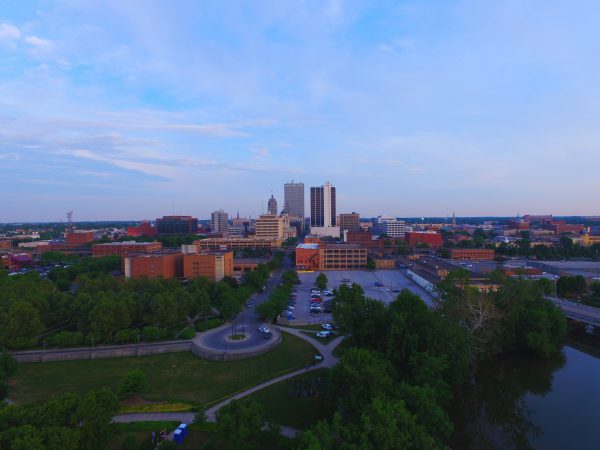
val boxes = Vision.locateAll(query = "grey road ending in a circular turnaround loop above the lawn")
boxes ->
[199,256,292,352]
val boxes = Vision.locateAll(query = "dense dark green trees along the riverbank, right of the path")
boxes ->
[299,273,566,450]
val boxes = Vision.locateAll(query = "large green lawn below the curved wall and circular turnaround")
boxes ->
[9,334,316,404]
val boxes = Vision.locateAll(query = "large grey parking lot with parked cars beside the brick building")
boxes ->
[293,270,432,323]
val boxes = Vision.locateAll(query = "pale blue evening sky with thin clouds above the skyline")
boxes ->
[0,0,600,222]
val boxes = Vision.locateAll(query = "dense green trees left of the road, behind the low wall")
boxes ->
[0,254,283,349]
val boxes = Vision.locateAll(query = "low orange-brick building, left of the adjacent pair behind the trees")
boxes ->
[123,250,183,278]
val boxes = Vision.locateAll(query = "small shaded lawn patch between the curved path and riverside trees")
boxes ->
[242,369,335,430]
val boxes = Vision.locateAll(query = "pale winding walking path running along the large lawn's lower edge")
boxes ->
[113,325,344,439]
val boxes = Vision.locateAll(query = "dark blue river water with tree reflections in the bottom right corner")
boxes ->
[452,346,600,450]
